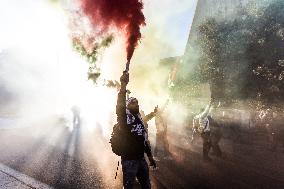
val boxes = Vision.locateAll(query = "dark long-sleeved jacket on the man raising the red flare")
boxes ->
[116,88,151,160]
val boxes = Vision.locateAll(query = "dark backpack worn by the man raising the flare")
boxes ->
[109,124,128,156]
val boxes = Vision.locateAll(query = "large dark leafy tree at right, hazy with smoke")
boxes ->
[194,0,284,103]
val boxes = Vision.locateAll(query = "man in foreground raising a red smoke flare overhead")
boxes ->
[116,71,156,189]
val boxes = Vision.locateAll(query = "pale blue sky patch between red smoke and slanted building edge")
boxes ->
[144,0,197,56]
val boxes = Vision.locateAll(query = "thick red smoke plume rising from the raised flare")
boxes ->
[79,0,145,61]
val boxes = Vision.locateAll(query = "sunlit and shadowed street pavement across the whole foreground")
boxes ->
[0,115,284,189]
